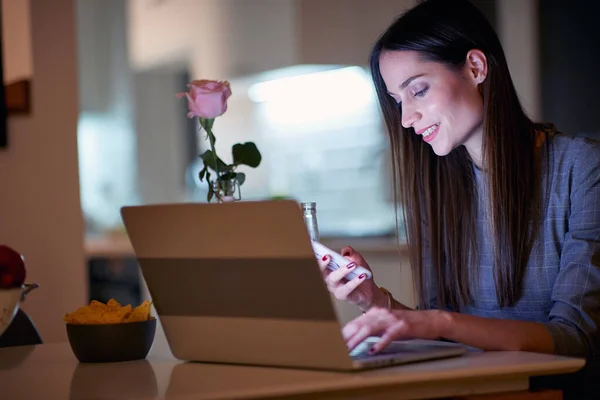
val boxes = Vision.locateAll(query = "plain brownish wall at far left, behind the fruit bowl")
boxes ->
[0,0,87,342]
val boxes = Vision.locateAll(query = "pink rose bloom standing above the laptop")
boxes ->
[177,79,231,118]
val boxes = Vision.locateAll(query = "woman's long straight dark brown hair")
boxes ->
[370,0,541,311]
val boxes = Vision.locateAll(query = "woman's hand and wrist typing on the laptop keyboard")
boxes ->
[342,307,446,353]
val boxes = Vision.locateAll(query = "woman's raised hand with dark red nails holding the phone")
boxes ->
[318,246,387,311]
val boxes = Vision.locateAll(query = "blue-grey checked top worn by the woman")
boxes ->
[430,126,600,359]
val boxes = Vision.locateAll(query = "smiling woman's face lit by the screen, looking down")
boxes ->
[379,51,487,165]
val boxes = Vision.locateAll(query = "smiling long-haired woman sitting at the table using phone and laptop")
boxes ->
[320,0,600,359]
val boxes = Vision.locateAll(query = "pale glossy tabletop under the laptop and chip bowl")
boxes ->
[0,336,585,400]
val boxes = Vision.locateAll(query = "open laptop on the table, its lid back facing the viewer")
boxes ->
[121,200,466,371]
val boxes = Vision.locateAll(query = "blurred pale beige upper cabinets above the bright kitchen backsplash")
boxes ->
[129,0,415,79]
